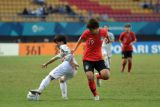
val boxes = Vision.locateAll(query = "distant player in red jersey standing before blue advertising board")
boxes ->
[119,23,137,73]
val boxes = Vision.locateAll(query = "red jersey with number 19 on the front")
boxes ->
[81,29,107,61]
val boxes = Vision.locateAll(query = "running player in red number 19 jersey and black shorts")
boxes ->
[72,19,110,100]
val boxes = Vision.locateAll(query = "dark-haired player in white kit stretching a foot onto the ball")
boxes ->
[30,36,79,99]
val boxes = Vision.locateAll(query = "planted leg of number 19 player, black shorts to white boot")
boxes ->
[83,61,99,100]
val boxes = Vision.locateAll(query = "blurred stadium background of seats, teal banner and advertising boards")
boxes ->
[0,0,160,56]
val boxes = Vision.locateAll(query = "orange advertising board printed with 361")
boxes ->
[19,42,85,56]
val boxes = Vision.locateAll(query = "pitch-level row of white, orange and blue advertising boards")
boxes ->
[0,42,160,56]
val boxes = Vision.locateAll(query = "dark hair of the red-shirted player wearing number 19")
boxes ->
[87,19,99,30]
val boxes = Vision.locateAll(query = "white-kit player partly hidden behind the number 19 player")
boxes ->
[102,26,115,69]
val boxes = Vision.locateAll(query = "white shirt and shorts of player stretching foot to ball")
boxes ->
[49,45,77,79]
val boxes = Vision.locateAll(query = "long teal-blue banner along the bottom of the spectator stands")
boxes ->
[0,22,160,36]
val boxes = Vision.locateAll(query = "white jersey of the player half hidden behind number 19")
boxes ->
[102,32,115,57]
